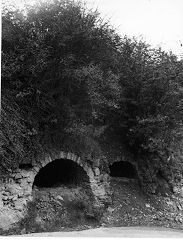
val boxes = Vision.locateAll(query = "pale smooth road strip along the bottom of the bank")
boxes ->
[16,227,183,238]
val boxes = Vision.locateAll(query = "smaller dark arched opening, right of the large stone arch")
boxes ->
[109,161,137,179]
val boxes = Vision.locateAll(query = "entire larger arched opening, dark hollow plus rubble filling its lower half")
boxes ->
[30,159,95,231]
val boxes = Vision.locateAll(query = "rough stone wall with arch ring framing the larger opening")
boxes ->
[0,151,110,229]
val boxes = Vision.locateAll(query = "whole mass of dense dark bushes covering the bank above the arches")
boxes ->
[0,0,183,191]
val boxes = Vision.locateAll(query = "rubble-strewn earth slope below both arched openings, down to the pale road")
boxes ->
[0,178,183,235]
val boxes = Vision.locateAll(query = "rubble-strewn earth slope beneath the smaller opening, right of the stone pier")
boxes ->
[102,177,183,229]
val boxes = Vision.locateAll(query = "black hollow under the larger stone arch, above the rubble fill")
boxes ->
[33,159,89,188]
